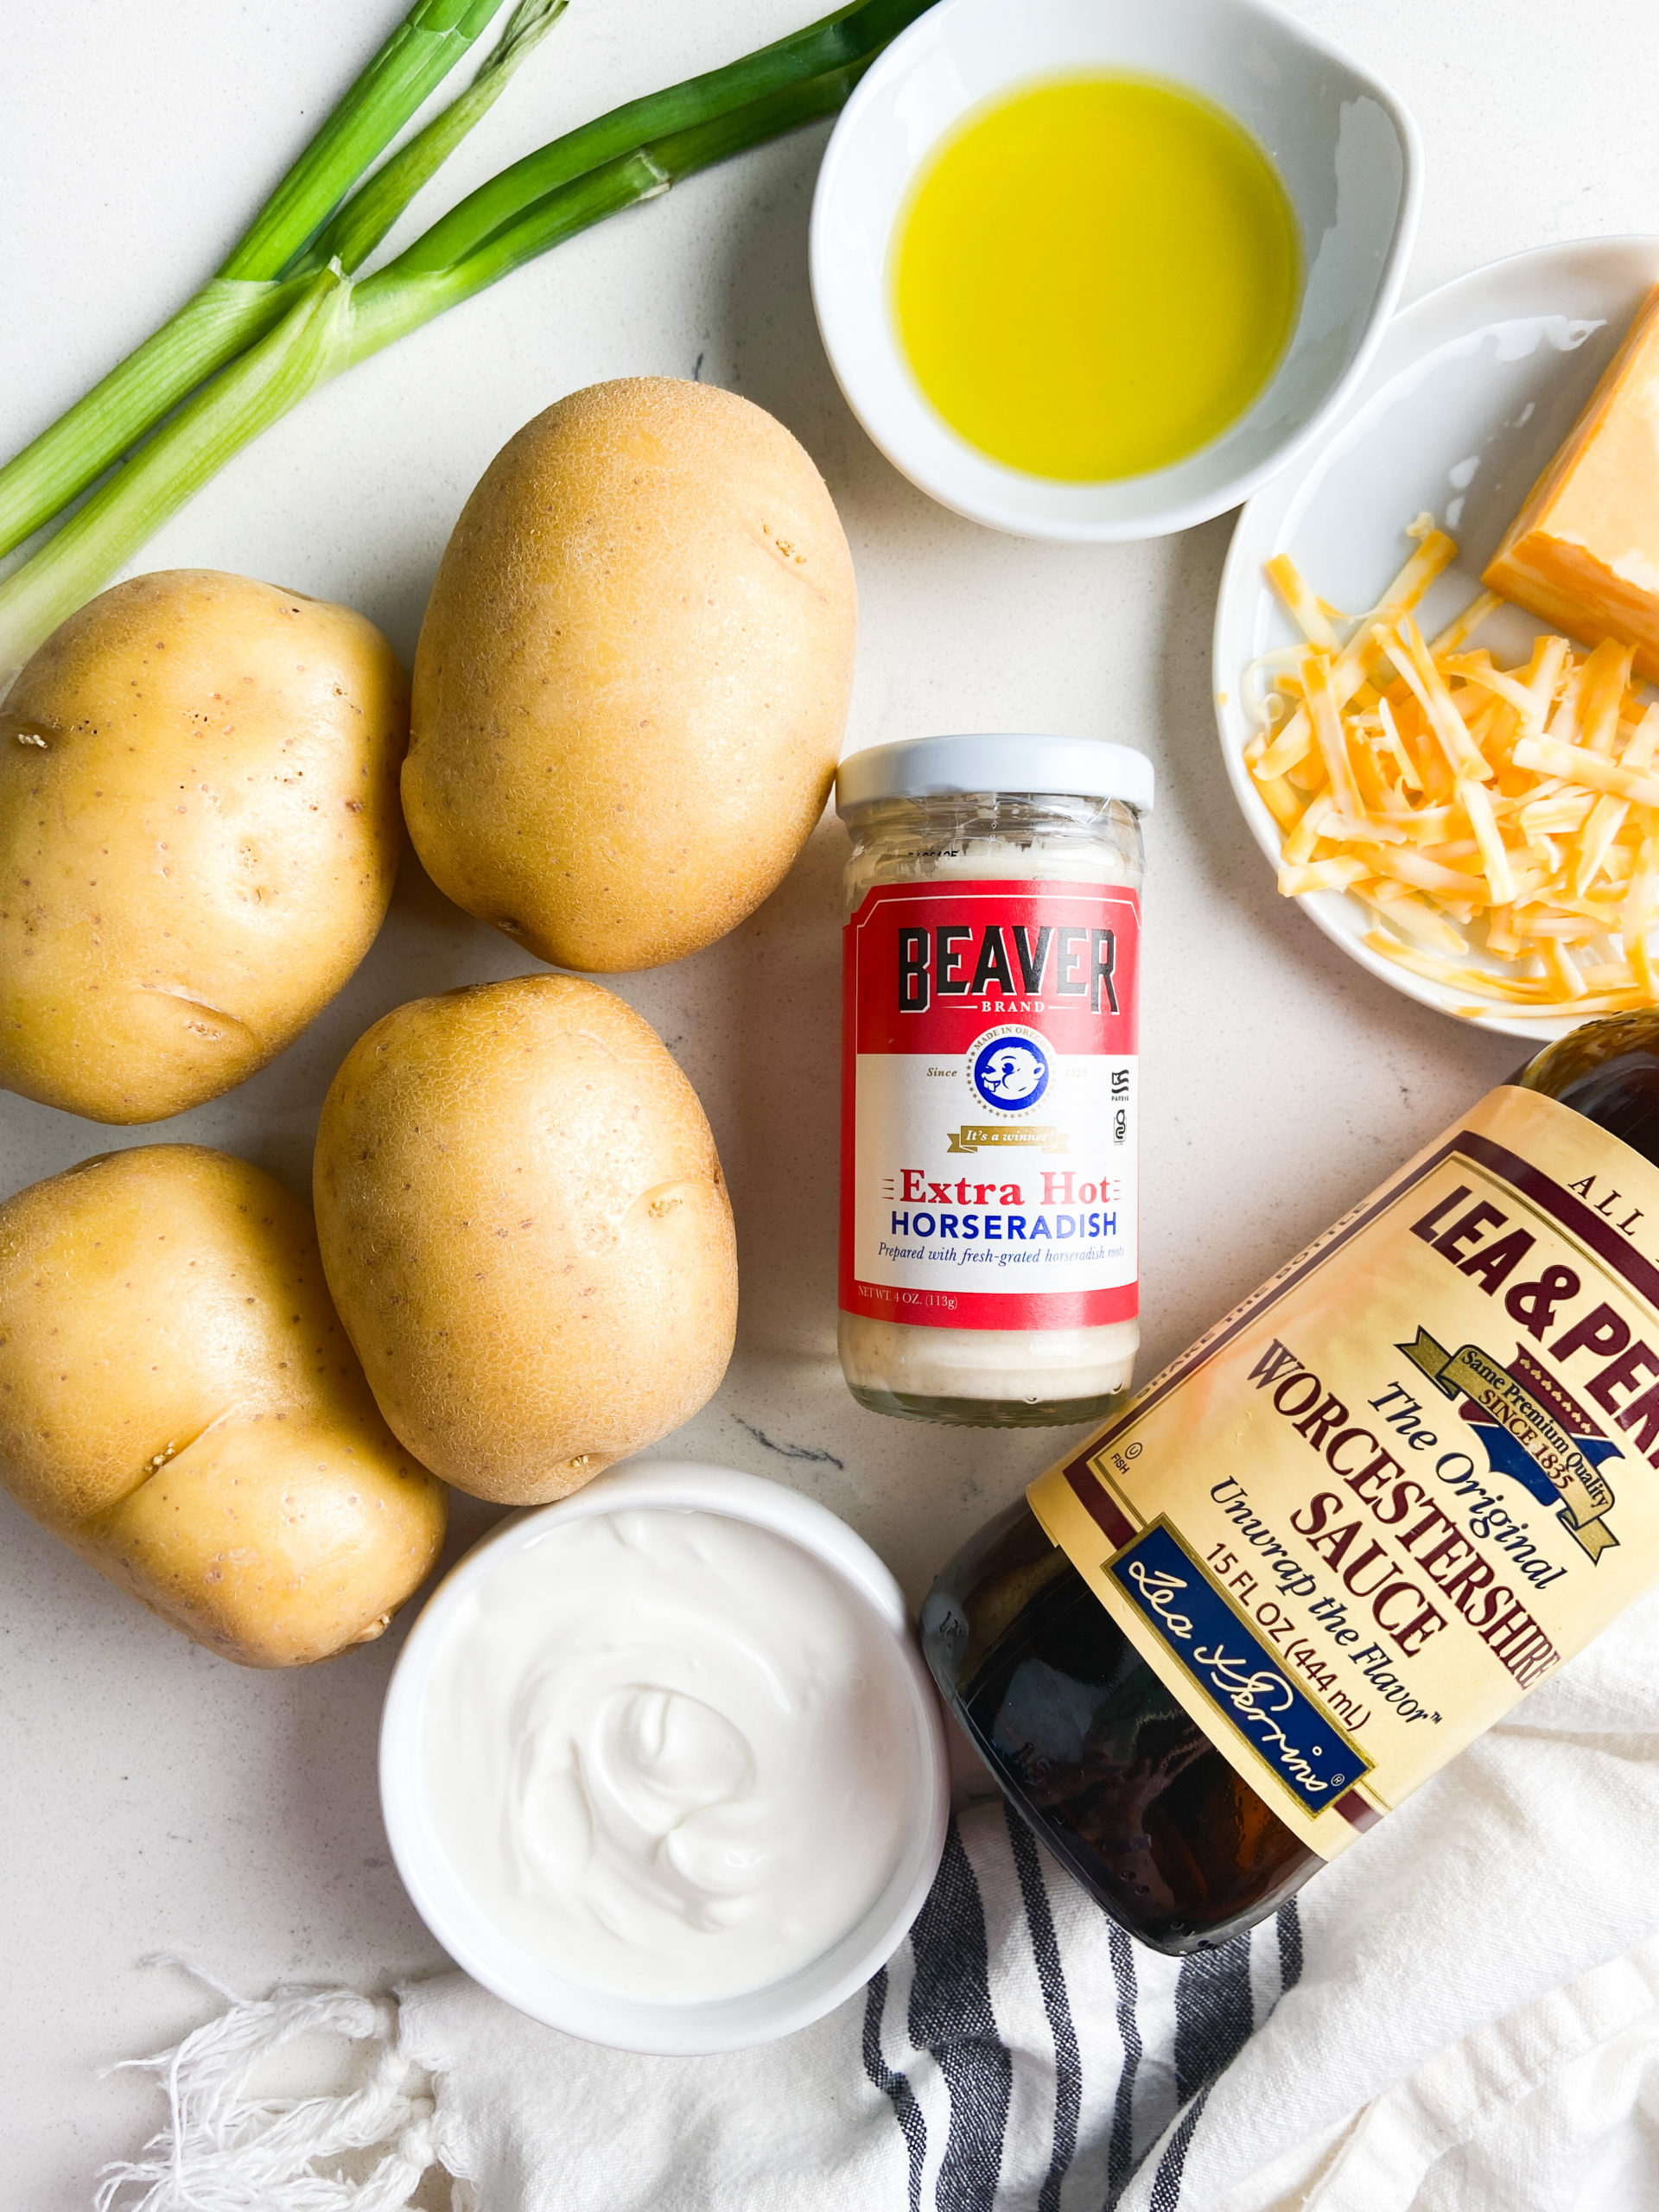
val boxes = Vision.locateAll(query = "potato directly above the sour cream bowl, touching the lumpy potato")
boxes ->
[315,976,736,1504]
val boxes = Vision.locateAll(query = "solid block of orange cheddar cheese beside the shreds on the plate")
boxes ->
[1482,288,1659,681]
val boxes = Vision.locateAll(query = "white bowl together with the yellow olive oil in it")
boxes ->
[812,0,1422,540]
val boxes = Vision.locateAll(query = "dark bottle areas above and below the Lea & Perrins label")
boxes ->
[923,1013,1659,1951]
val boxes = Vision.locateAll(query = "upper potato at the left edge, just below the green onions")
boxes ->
[0,569,407,1122]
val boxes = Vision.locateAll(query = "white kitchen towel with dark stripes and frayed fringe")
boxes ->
[99,1597,1659,2212]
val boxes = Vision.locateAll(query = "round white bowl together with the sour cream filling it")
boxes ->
[380,1462,949,2053]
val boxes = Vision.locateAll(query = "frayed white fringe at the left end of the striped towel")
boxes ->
[95,1958,434,2212]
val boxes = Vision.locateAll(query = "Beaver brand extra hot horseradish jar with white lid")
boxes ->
[836,736,1153,1427]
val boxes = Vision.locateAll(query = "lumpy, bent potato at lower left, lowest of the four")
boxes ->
[0,1144,447,1666]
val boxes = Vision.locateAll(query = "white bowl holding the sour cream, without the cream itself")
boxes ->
[380,1460,951,2053]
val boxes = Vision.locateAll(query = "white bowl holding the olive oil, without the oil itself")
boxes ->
[812,0,1422,542]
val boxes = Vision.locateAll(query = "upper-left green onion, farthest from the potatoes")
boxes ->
[0,0,526,556]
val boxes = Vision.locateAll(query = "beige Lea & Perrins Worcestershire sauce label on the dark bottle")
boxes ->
[1028,1089,1659,1858]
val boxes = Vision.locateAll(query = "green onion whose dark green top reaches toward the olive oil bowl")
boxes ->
[0,0,931,681]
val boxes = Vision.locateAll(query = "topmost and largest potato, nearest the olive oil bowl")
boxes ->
[403,376,856,971]
